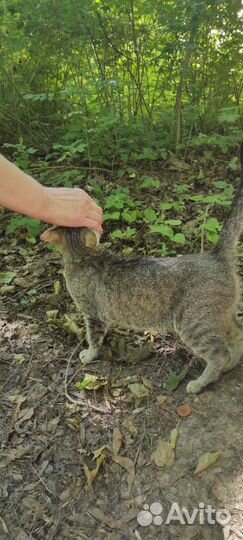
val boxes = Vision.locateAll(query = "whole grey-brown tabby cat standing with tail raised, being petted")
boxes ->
[41,143,243,393]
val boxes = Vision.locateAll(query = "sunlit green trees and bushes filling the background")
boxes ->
[0,0,243,160]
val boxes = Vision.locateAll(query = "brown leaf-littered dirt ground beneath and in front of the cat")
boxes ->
[0,157,243,540]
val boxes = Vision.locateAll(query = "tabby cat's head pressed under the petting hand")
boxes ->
[40,227,100,253]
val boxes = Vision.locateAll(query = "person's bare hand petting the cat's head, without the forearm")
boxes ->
[43,187,103,233]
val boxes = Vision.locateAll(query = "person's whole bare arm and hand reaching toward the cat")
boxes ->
[0,155,103,233]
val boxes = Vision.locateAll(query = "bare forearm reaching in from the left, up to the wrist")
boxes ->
[0,155,48,220]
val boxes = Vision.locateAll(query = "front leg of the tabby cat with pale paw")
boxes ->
[79,317,106,364]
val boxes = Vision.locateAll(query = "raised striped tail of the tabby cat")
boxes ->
[214,143,243,257]
